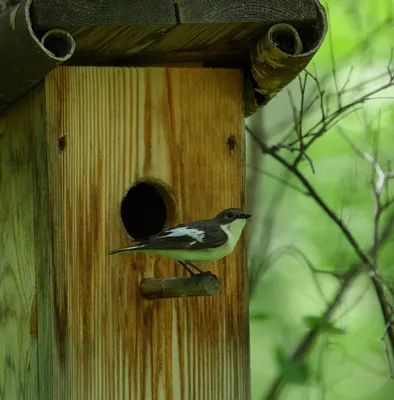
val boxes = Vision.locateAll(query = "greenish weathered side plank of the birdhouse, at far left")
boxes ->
[0,96,40,400]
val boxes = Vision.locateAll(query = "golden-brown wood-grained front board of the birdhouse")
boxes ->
[39,67,250,400]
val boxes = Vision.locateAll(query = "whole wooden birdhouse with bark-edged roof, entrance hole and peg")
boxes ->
[0,0,327,400]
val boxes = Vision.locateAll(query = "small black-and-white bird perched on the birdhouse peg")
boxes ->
[110,208,251,275]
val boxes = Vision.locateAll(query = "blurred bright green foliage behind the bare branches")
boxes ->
[248,0,394,400]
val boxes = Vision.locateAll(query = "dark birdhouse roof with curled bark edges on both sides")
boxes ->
[0,0,327,112]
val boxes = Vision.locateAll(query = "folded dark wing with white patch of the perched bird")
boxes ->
[138,221,227,250]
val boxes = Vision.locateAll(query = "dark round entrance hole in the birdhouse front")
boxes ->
[120,179,175,240]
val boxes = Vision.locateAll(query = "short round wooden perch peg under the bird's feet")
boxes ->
[140,272,222,300]
